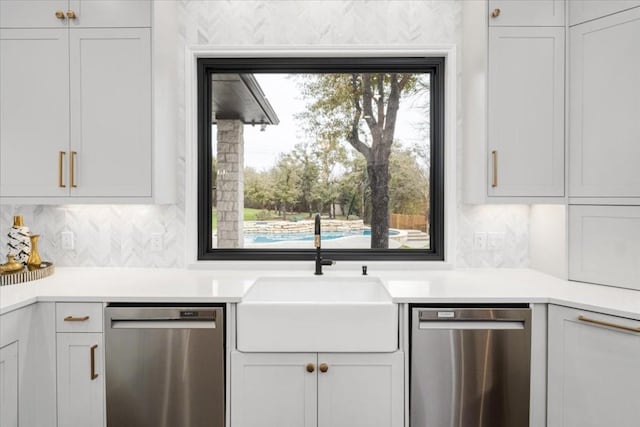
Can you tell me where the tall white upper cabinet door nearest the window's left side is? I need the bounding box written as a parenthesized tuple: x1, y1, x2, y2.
(69, 28, 152, 198)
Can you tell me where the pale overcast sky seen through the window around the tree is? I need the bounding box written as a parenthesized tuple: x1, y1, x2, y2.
(213, 74, 427, 171)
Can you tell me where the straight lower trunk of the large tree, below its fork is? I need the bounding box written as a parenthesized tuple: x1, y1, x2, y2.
(367, 163, 389, 249)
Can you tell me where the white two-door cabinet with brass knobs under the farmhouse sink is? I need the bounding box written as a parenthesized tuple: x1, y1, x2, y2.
(231, 352, 404, 427)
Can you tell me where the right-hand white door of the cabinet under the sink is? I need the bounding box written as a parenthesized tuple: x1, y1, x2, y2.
(318, 352, 404, 427)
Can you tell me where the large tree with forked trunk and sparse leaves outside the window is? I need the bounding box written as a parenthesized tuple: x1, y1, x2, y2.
(300, 73, 417, 248)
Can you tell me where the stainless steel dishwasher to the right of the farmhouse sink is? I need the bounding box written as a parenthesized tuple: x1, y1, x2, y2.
(410, 307, 531, 427)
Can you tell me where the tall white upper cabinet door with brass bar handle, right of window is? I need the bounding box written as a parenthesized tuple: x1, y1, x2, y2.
(487, 27, 564, 197)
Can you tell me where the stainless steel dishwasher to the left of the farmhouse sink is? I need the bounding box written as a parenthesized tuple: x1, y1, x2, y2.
(105, 304, 225, 427)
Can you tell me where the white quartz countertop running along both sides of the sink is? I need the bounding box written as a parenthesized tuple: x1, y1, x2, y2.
(0, 268, 640, 319)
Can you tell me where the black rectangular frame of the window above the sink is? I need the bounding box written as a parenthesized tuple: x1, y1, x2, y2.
(197, 56, 445, 261)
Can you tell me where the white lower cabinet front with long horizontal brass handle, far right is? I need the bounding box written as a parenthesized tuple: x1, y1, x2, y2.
(548, 305, 640, 427)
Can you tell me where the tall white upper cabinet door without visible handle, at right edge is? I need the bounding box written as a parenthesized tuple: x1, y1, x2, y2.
(569, 8, 640, 197)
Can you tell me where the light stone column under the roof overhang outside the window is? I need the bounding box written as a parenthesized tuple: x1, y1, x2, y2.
(216, 120, 244, 248)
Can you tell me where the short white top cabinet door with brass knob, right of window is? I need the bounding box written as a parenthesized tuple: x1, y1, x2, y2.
(489, 0, 565, 27)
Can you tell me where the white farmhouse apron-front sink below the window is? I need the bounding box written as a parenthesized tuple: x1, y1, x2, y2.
(237, 276, 398, 352)
